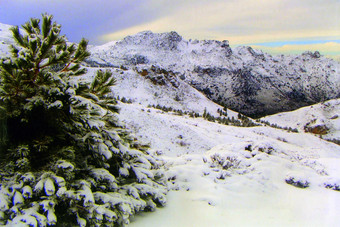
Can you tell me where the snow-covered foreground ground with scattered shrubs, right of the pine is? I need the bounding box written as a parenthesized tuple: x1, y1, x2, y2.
(120, 104, 340, 226)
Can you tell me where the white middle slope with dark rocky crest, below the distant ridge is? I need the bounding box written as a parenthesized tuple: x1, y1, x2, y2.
(87, 64, 238, 118)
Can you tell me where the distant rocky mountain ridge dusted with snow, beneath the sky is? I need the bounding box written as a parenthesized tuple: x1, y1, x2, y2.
(89, 31, 340, 116)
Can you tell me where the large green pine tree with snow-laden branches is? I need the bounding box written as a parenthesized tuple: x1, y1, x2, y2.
(0, 14, 167, 226)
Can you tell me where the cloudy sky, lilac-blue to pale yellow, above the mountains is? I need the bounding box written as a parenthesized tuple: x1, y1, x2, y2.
(0, 0, 340, 56)
